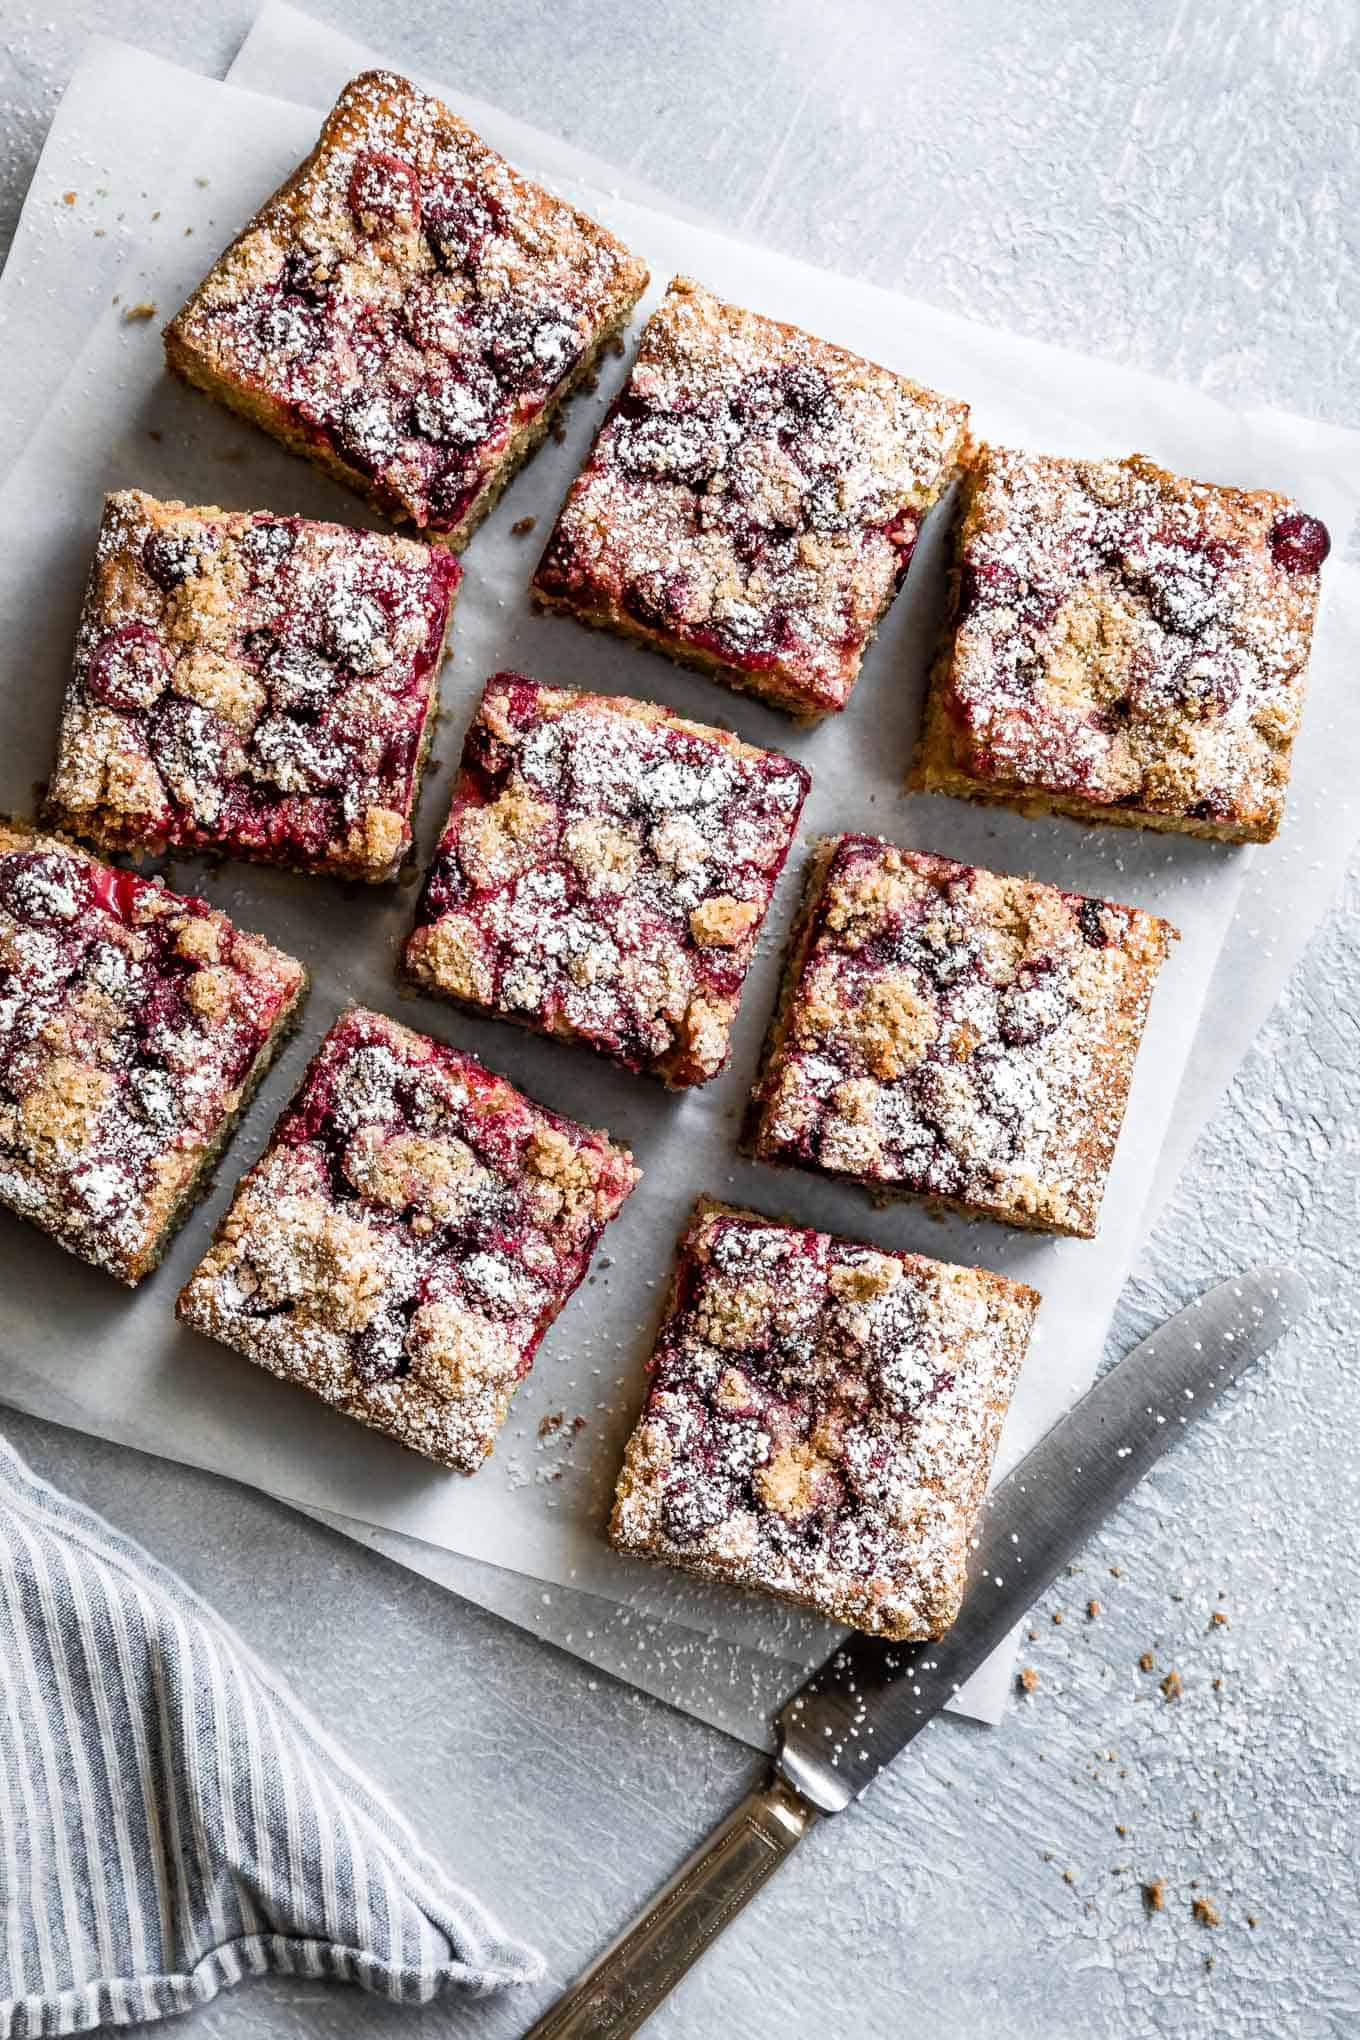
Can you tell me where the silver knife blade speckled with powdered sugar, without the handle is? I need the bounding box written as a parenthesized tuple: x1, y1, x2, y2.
(777, 1267, 1309, 1814)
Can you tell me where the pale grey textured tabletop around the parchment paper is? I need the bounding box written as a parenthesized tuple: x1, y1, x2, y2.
(0, 0, 1360, 2040)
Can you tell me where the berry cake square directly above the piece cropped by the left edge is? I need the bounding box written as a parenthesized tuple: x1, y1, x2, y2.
(49, 490, 461, 883)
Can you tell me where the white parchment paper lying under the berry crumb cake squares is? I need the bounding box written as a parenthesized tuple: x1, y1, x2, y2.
(0, 19, 1360, 1716)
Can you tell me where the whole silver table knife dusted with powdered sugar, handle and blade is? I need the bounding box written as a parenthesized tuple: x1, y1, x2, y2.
(524, 1267, 1309, 2040)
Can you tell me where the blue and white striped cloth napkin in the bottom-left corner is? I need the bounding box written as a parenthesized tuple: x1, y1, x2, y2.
(0, 1438, 542, 2040)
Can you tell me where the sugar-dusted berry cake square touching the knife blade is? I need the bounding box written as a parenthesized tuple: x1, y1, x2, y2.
(610, 1197, 1040, 1642)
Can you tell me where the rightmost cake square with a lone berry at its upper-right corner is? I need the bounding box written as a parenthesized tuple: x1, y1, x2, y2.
(911, 447, 1331, 843)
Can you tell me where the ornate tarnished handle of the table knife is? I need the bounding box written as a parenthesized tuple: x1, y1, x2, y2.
(524, 1779, 818, 2040)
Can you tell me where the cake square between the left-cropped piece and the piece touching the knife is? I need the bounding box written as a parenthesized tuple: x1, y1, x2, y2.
(177, 1006, 638, 1473)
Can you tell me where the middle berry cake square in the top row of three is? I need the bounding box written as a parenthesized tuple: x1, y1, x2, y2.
(532, 277, 969, 720)
